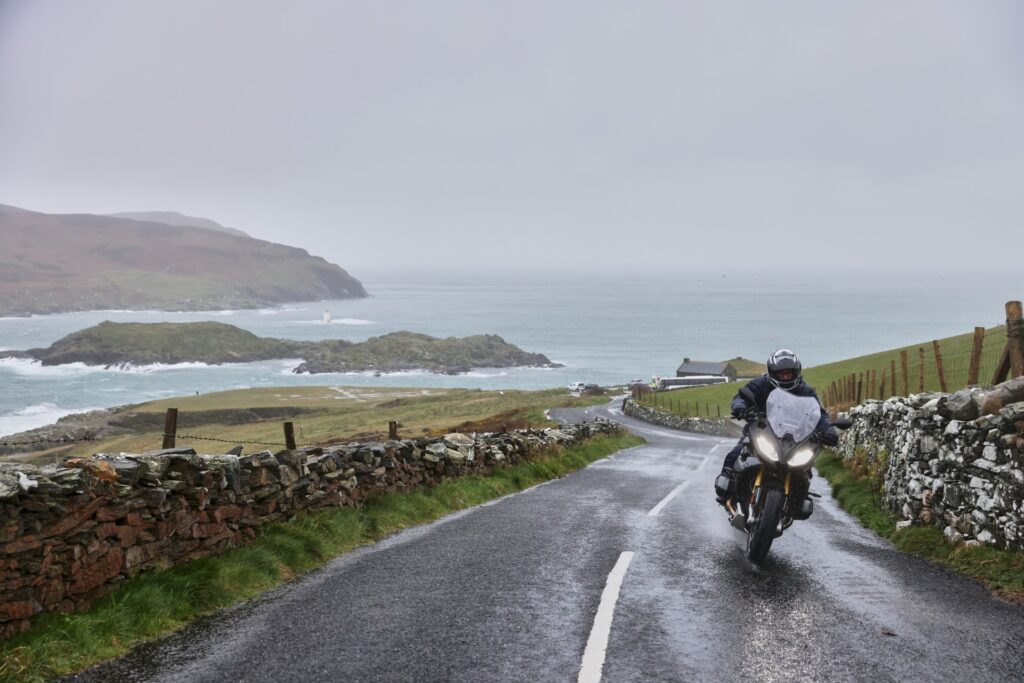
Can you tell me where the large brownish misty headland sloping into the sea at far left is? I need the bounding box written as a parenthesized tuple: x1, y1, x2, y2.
(0, 205, 367, 315)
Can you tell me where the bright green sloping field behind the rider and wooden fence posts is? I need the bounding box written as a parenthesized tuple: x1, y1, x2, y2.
(641, 326, 1007, 417)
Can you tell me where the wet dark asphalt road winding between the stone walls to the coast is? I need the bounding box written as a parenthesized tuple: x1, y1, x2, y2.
(68, 401, 1024, 682)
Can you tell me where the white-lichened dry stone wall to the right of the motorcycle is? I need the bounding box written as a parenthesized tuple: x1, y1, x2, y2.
(839, 387, 1024, 550)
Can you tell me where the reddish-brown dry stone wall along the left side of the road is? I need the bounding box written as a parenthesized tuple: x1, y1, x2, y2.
(0, 422, 623, 638)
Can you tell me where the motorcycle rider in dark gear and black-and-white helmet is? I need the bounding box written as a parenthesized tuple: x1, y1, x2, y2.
(715, 348, 839, 505)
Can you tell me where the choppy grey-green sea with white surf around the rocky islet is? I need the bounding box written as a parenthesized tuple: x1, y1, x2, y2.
(0, 265, 1007, 435)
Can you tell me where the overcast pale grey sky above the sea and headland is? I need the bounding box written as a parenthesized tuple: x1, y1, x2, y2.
(0, 0, 1024, 275)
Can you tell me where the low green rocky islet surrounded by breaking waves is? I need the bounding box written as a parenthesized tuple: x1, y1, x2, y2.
(9, 321, 558, 375)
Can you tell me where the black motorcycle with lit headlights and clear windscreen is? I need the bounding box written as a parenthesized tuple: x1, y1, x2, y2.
(722, 390, 853, 564)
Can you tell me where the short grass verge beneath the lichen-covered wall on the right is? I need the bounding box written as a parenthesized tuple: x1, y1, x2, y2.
(815, 451, 1024, 604)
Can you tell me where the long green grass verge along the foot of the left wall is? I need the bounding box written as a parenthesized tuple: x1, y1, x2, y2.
(0, 434, 643, 682)
